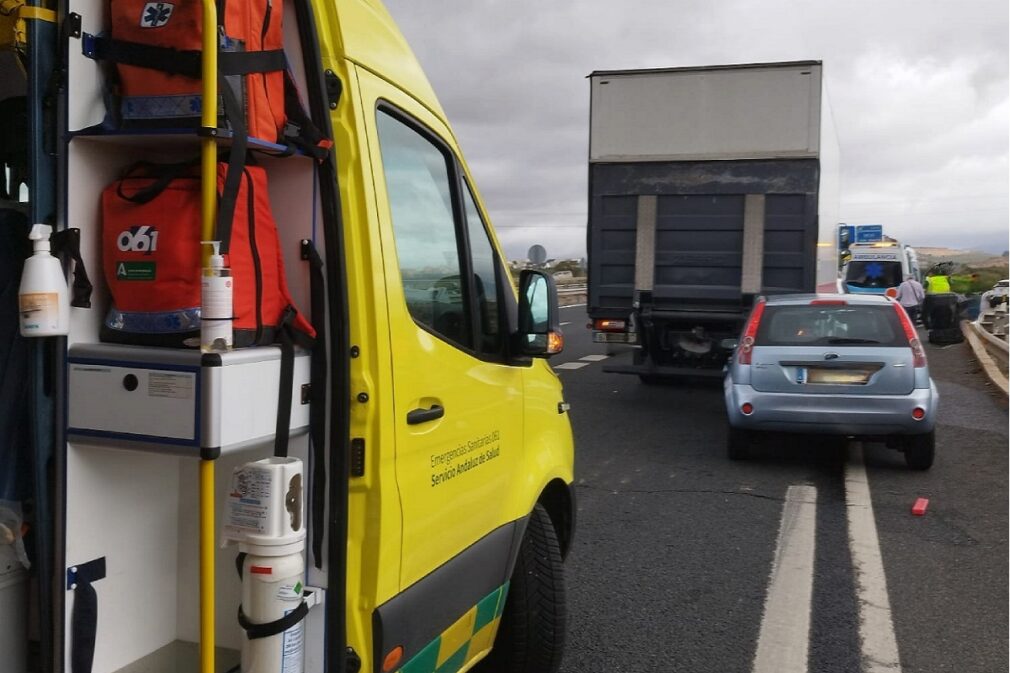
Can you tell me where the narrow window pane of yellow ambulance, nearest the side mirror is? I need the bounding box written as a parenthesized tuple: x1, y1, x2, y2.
(463, 183, 501, 355)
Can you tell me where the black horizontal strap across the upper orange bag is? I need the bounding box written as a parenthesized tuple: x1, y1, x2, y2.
(85, 35, 288, 80)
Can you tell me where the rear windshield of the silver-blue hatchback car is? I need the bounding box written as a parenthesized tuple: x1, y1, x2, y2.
(754, 304, 908, 347)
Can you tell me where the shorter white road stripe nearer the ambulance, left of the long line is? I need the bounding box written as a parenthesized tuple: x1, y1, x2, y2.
(751, 485, 817, 673)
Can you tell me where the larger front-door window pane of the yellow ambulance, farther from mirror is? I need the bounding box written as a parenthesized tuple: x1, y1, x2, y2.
(377, 110, 472, 347)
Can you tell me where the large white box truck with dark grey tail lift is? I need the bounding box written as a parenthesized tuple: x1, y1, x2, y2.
(587, 61, 838, 381)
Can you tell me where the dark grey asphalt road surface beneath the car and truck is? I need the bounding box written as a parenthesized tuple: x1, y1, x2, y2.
(551, 306, 1010, 673)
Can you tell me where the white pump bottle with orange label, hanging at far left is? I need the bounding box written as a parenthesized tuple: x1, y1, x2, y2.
(18, 224, 70, 337)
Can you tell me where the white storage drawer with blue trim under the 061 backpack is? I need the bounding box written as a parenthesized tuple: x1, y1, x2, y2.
(67, 344, 310, 459)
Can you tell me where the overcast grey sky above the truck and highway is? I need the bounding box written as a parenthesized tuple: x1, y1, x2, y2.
(387, 0, 1010, 258)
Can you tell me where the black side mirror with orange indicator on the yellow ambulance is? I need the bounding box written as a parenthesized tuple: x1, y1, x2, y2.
(513, 269, 565, 358)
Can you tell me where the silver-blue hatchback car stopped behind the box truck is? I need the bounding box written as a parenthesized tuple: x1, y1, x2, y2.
(724, 294, 938, 470)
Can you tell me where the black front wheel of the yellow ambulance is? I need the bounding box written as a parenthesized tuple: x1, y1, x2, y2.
(475, 504, 567, 673)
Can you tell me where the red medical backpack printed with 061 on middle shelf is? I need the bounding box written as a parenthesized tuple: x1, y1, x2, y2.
(101, 163, 315, 347)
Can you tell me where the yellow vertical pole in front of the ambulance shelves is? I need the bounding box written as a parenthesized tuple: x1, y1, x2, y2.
(200, 0, 217, 673)
